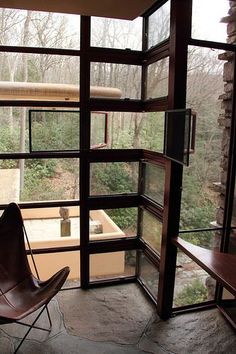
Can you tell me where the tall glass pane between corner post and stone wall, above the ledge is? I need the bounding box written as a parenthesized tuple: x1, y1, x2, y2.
(181, 46, 230, 229)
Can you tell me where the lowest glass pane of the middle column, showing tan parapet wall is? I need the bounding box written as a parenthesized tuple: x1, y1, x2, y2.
(90, 251, 136, 281)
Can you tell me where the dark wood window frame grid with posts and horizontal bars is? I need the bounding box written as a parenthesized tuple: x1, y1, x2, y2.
(0, 0, 236, 328)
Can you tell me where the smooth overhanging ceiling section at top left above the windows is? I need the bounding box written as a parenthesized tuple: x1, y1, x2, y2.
(0, 0, 159, 20)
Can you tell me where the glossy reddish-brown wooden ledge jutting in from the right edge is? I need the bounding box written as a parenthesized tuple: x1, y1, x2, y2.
(172, 237, 236, 296)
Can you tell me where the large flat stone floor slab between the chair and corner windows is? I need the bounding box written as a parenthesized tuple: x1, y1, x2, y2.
(58, 284, 155, 344)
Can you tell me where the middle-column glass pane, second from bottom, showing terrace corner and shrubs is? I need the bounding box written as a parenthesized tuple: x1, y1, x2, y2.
(90, 208, 138, 240)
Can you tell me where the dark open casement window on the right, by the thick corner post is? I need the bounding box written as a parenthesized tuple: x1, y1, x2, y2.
(164, 109, 196, 166)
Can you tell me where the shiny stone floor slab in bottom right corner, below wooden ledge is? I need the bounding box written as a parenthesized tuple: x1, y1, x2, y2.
(140, 309, 236, 354)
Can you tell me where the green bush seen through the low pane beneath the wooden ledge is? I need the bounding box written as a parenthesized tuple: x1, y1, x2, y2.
(175, 279, 207, 307)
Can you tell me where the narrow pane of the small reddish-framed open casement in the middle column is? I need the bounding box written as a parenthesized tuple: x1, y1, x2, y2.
(90, 112, 108, 149)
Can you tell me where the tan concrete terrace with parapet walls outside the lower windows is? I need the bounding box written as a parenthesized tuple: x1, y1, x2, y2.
(22, 207, 125, 280)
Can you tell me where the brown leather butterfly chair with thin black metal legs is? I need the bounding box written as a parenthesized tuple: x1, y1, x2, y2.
(0, 203, 70, 353)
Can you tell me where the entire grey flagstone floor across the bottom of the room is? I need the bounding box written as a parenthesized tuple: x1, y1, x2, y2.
(0, 284, 236, 354)
